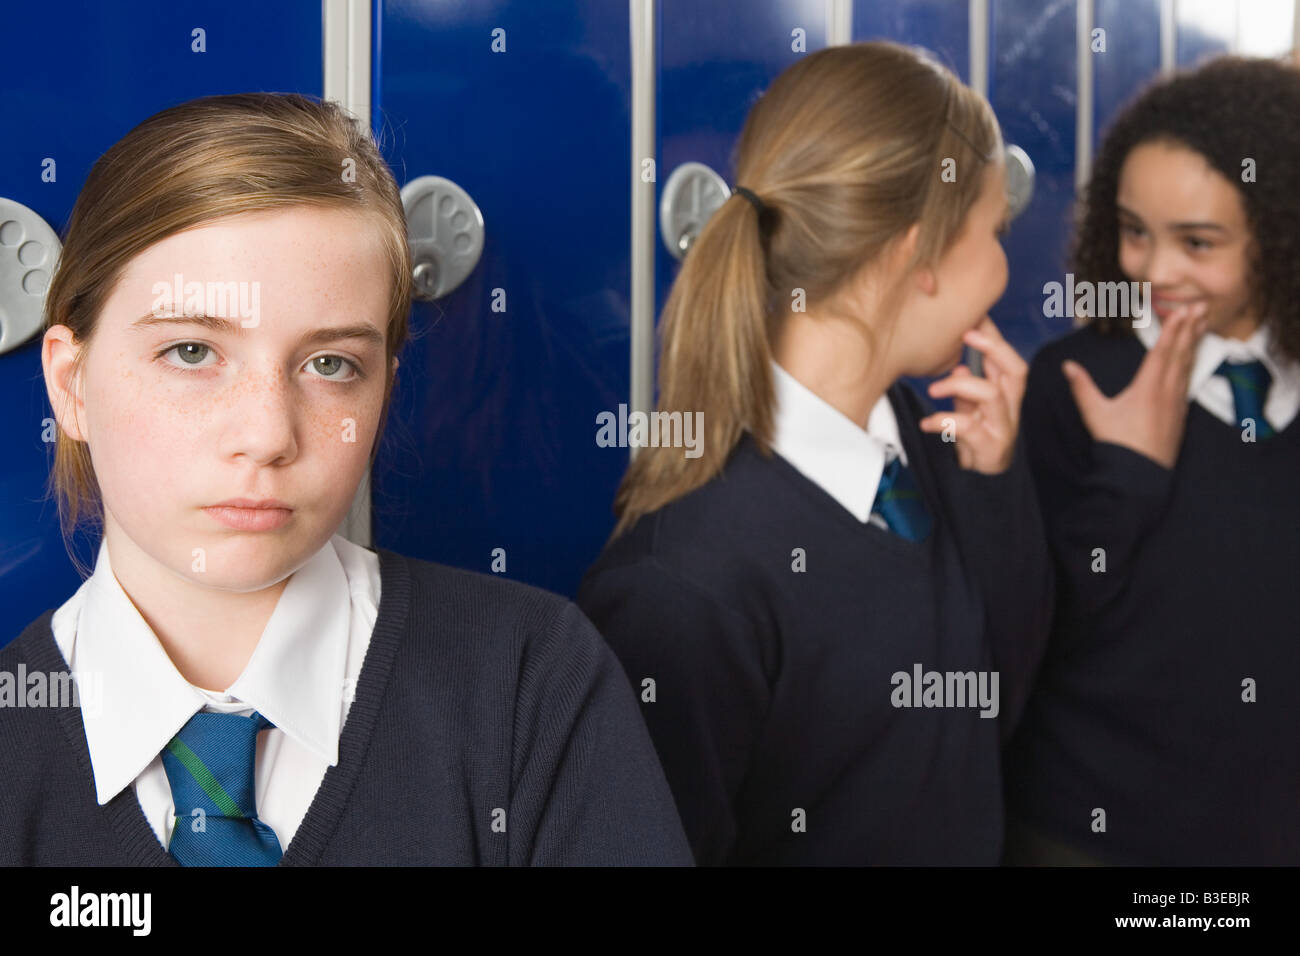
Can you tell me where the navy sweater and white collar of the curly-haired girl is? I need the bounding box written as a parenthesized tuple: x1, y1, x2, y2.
(1008, 317, 1300, 865)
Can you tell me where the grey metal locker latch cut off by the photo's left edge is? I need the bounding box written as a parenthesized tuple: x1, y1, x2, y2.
(0, 198, 64, 355)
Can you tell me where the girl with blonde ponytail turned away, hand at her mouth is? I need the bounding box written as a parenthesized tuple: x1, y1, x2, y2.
(579, 43, 1052, 864)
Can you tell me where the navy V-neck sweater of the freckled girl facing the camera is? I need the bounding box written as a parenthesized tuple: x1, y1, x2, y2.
(0, 549, 690, 866)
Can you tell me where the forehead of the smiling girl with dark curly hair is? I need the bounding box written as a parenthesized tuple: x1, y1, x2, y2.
(1117, 142, 1244, 222)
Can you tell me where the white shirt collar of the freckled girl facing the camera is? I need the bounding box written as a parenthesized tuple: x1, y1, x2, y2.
(52, 541, 351, 804)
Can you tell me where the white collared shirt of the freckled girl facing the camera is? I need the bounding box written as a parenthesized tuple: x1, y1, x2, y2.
(51, 535, 380, 849)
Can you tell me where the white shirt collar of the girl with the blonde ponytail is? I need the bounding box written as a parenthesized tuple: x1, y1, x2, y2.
(772, 362, 907, 527)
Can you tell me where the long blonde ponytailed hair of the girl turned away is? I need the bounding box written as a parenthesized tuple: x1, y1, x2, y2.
(614, 42, 1001, 537)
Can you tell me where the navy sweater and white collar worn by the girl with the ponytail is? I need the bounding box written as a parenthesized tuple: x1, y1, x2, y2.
(577, 364, 1050, 865)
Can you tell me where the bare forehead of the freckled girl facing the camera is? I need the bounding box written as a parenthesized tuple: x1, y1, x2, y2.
(109, 207, 391, 329)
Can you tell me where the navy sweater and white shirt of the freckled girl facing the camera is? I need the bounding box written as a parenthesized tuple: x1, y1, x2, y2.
(0, 535, 690, 866)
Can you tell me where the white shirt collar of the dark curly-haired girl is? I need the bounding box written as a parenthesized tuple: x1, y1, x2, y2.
(1134, 312, 1300, 432)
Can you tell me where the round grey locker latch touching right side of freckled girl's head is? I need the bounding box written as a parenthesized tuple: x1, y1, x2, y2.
(402, 176, 484, 302)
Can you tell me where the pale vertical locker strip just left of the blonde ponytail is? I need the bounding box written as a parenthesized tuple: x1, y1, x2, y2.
(628, 0, 659, 447)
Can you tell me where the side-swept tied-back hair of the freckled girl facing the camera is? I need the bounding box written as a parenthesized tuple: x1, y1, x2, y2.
(44, 92, 411, 572)
